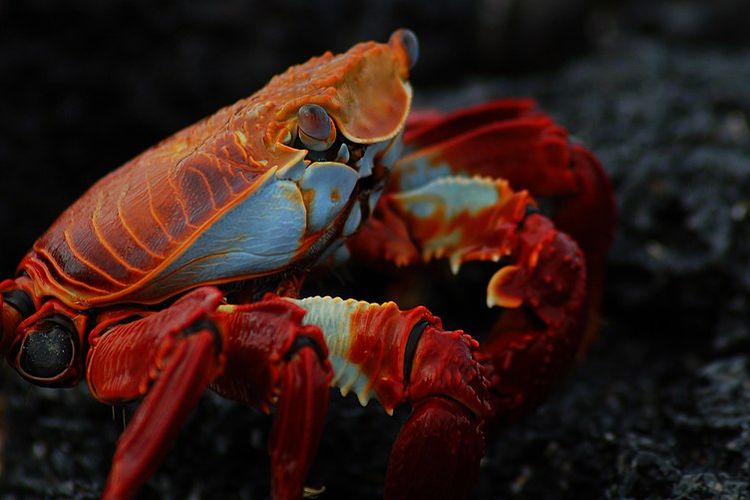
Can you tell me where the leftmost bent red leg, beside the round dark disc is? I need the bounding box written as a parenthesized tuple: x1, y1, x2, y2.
(86, 288, 223, 498)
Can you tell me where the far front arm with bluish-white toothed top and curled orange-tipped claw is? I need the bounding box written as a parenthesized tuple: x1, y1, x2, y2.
(352, 177, 587, 422)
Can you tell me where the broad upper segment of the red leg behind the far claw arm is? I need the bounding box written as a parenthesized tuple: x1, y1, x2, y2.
(400, 99, 578, 197)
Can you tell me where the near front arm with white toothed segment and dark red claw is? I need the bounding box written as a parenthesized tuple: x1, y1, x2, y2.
(294, 297, 490, 499)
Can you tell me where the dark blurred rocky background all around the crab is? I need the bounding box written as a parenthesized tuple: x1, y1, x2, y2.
(0, 0, 750, 498)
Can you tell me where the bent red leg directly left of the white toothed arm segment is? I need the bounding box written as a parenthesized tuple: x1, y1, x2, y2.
(212, 295, 333, 498)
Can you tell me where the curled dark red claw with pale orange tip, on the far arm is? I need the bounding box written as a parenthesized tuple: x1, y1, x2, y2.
(477, 214, 587, 424)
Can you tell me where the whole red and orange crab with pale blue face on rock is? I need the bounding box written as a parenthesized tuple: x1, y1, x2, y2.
(0, 30, 615, 498)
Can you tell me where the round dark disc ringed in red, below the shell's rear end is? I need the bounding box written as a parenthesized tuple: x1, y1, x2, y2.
(18, 318, 75, 380)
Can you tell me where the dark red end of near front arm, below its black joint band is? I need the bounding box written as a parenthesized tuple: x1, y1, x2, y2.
(385, 323, 489, 499)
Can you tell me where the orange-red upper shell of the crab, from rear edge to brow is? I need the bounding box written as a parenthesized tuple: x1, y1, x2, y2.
(19, 37, 411, 309)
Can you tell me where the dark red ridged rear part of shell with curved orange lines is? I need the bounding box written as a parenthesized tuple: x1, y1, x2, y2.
(27, 116, 274, 303)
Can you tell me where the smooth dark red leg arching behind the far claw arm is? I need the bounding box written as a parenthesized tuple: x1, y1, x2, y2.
(389, 99, 616, 350)
